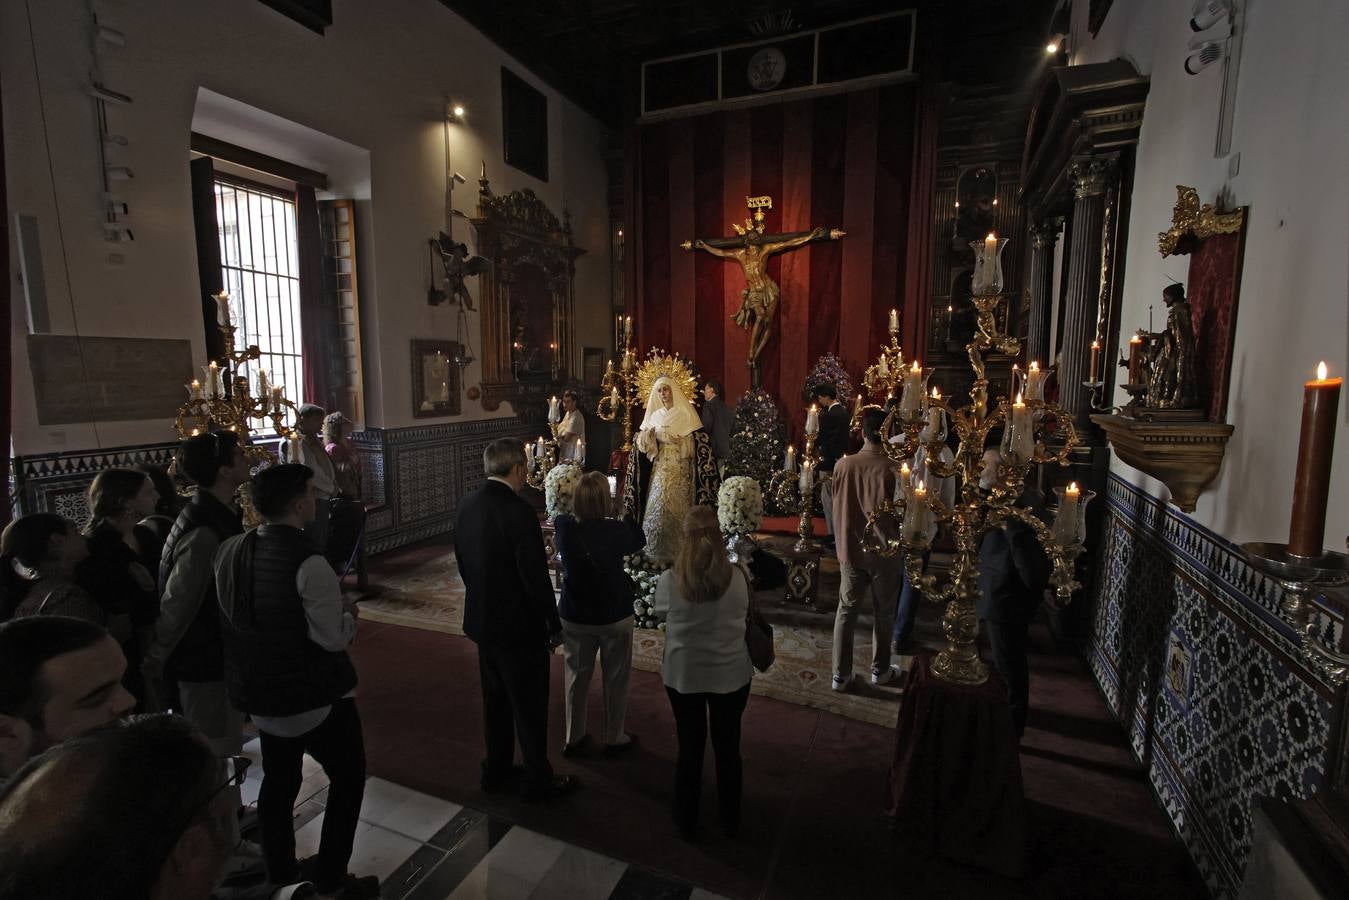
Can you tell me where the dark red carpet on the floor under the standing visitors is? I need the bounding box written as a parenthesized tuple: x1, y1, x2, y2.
(353, 542, 1205, 900)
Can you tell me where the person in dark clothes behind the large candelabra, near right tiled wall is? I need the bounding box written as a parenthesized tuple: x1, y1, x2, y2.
(975, 488, 1050, 738)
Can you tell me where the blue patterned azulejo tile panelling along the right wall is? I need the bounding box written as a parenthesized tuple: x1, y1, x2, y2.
(1087, 475, 1342, 897)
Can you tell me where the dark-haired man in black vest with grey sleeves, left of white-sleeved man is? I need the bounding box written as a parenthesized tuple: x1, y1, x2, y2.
(142, 432, 248, 758)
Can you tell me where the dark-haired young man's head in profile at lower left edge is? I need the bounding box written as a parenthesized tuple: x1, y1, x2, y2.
(0, 615, 136, 780)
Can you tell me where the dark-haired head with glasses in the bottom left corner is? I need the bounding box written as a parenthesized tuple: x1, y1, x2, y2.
(0, 715, 237, 900)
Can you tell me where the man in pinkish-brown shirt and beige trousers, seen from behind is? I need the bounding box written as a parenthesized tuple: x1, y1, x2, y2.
(831, 406, 902, 691)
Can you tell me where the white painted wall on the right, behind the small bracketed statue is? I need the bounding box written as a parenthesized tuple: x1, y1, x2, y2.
(1072, 0, 1349, 551)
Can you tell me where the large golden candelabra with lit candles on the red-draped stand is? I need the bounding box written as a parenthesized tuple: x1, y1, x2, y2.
(863, 235, 1094, 684)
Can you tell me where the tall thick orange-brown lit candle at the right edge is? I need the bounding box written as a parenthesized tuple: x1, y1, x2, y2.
(1288, 363, 1344, 556)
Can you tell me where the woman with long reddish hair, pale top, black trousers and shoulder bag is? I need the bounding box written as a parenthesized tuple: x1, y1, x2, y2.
(654, 506, 753, 841)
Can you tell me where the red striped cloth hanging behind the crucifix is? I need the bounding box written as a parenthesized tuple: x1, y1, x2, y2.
(626, 85, 931, 441)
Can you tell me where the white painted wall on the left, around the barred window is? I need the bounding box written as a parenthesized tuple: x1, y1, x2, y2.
(0, 0, 610, 453)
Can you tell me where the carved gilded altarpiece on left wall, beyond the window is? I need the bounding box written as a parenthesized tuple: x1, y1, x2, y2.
(472, 173, 585, 413)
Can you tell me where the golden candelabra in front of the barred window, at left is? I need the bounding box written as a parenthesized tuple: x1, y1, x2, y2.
(174, 291, 295, 463)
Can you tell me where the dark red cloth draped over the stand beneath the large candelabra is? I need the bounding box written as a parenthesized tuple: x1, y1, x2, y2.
(885, 656, 1027, 878)
